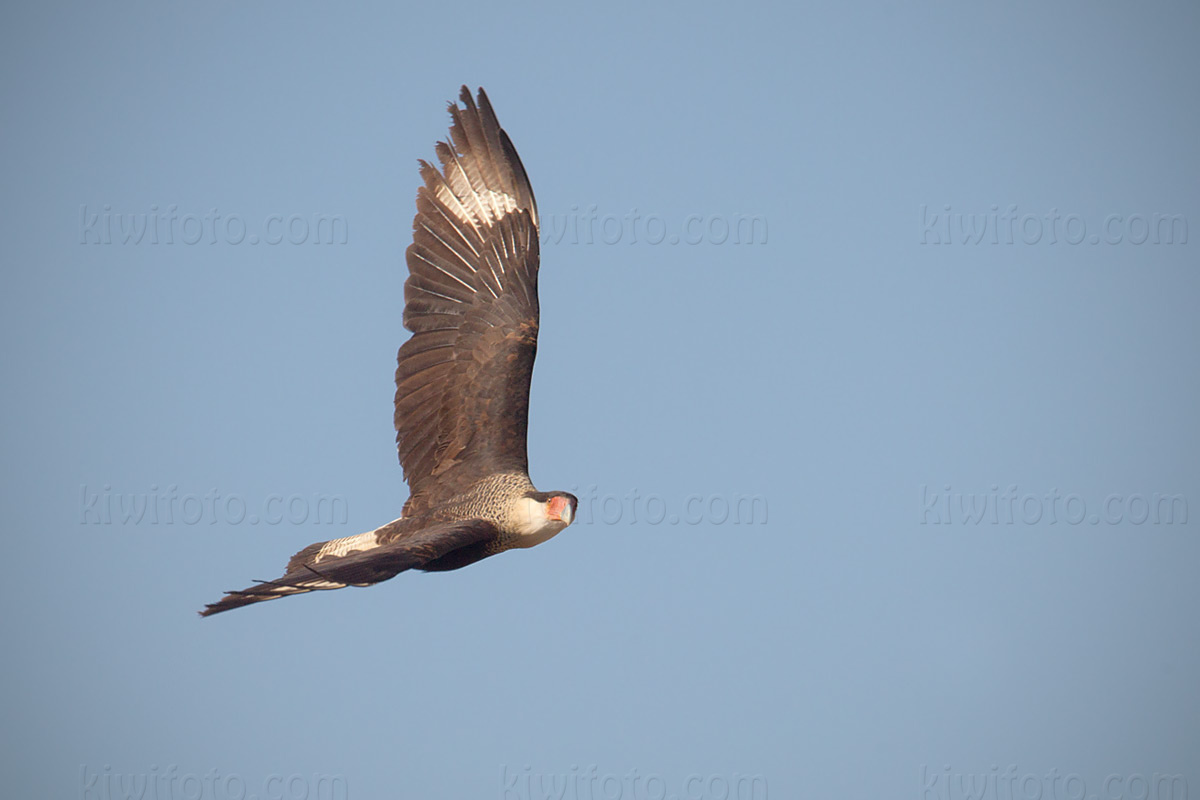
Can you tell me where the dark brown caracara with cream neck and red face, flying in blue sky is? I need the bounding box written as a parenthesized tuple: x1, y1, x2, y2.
(200, 86, 578, 616)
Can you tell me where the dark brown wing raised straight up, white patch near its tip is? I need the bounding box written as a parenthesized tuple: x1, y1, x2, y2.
(395, 86, 538, 517)
